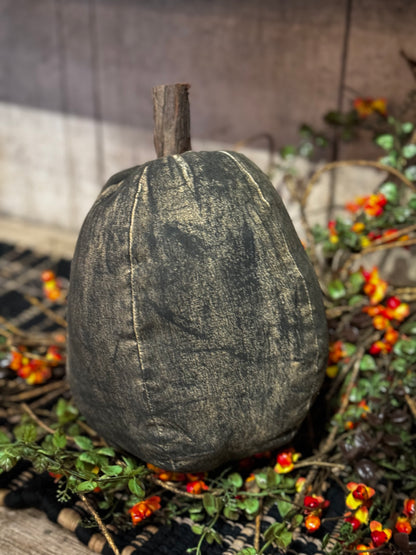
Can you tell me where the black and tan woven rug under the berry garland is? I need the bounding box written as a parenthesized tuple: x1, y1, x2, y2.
(0, 243, 344, 555)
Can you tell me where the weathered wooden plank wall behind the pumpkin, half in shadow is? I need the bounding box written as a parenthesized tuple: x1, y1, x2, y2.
(0, 0, 416, 230)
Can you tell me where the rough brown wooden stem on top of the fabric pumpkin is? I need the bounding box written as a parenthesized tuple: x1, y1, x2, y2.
(153, 83, 191, 158)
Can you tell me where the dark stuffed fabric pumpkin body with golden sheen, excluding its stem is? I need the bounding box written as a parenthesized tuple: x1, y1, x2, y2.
(68, 151, 327, 471)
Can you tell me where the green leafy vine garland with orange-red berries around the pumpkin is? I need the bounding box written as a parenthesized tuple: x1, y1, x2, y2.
(0, 99, 416, 555)
